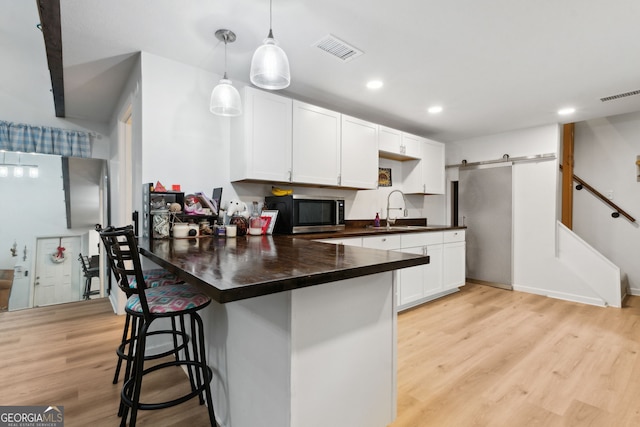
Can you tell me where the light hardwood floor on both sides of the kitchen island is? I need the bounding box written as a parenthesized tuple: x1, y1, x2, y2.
(0, 284, 640, 427)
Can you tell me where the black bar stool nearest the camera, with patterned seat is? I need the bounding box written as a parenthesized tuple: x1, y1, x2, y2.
(96, 226, 216, 427)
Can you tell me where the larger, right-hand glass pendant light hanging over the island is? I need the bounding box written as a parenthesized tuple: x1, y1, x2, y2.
(249, 0, 291, 90)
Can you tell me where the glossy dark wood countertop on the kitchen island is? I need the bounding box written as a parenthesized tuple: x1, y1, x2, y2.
(140, 235, 429, 303)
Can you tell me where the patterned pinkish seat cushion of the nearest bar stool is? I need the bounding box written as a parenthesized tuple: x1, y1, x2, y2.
(127, 285, 211, 313)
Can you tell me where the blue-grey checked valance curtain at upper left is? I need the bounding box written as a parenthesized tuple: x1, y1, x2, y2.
(0, 120, 91, 157)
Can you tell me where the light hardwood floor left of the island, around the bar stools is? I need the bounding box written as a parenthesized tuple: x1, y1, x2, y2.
(0, 299, 209, 427)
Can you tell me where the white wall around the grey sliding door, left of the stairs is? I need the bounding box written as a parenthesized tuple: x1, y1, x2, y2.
(446, 125, 598, 303)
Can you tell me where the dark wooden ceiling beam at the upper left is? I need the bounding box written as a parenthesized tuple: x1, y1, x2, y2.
(37, 0, 65, 117)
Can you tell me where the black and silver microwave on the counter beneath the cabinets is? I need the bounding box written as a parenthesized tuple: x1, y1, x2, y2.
(265, 194, 344, 234)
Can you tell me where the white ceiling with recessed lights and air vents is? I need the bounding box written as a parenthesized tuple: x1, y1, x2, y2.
(22, 0, 640, 141)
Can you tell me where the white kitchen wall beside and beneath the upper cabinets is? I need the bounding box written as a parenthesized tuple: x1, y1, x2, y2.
(136, 52, 444, 227)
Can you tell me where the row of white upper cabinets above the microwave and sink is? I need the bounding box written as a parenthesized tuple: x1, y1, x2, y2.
(230, 86, 445, 194)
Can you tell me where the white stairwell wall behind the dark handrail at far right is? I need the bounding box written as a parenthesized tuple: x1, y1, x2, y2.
(573, 112, 640, 295)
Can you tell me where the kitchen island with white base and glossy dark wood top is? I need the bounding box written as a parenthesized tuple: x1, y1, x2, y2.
(140, 236, 429, 427)
